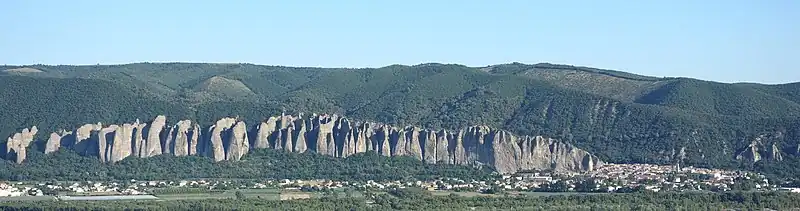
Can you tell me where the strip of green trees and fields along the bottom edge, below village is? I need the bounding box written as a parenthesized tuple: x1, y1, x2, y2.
(0, 188, 800, 210)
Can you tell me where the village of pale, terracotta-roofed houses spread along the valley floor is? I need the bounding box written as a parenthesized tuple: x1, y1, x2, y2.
(0, 164, 800, 197)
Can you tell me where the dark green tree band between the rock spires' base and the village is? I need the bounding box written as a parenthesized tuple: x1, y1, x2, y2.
(0, 149, 493, 181)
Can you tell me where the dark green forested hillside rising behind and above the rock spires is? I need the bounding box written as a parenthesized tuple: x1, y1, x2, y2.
(0, 63, 800, 176)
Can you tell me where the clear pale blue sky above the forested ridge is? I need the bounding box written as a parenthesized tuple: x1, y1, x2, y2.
(0, 0, 800, 83)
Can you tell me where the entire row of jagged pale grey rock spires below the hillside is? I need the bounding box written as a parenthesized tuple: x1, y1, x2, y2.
(0, 114, 603, 173)
